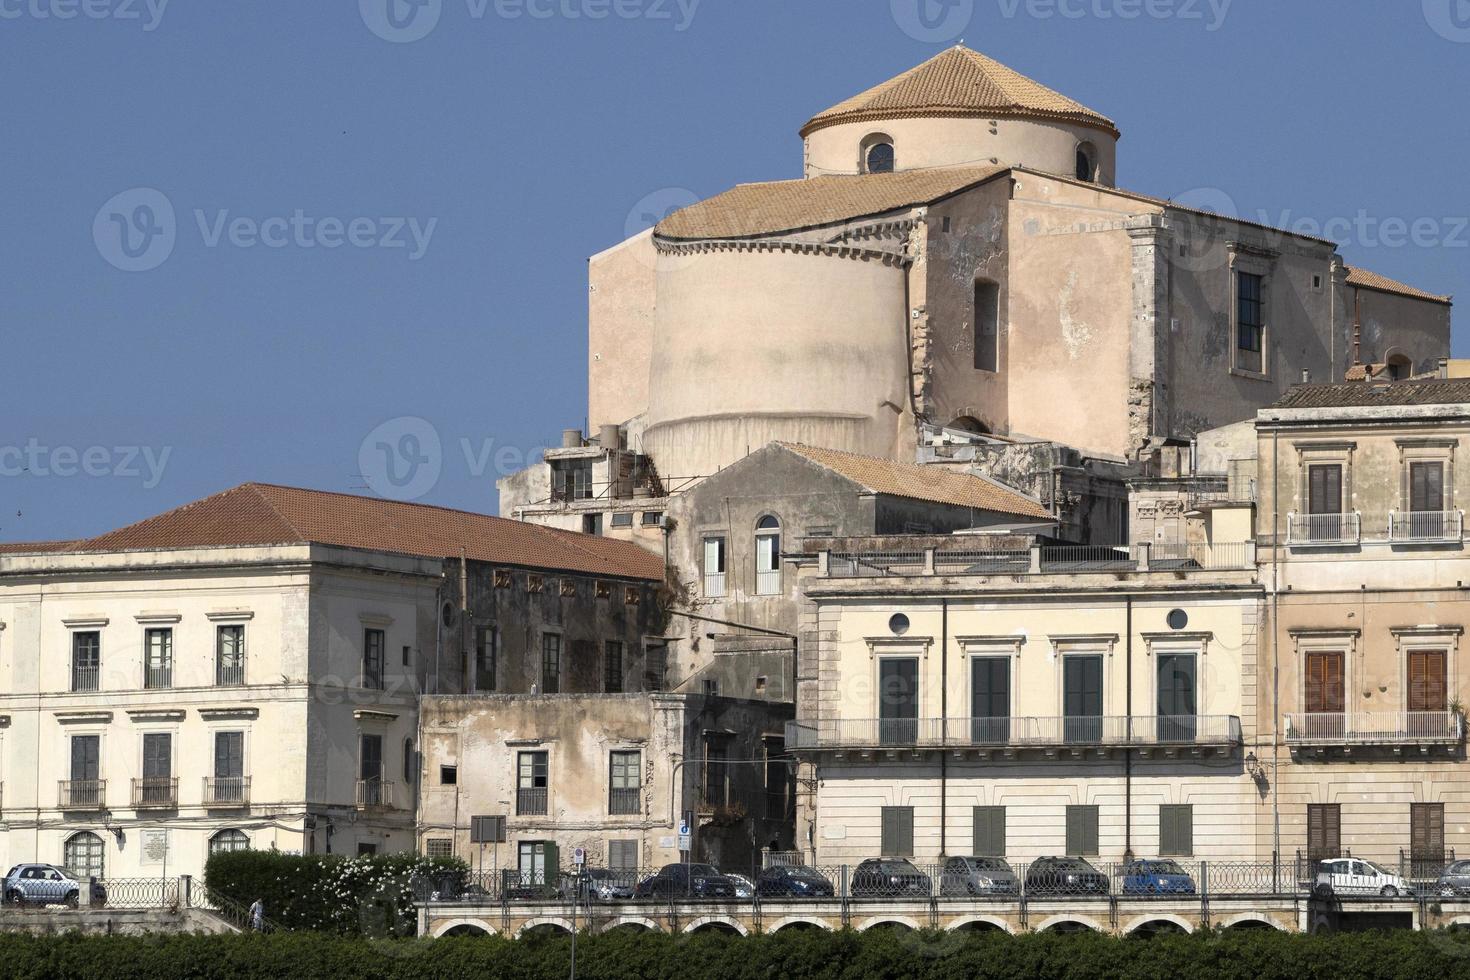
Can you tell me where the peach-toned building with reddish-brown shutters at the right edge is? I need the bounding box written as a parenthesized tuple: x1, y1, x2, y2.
(1257, 379, 1470, 877)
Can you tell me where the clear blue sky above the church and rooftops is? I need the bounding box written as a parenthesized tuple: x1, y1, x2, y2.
(0, 0, 1470, 541)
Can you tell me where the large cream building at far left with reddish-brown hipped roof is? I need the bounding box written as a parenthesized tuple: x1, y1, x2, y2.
(0, 483, 662, 879)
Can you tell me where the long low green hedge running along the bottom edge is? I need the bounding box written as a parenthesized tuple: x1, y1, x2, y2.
(0, 930, 1470, 980)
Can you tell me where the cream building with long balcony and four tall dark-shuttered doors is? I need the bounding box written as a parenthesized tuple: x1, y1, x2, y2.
(788, 536, 1269, 864)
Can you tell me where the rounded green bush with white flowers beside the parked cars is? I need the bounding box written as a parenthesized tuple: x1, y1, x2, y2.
(204, 851, 465, 937)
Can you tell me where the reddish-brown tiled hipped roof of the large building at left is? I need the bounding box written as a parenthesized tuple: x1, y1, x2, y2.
(45, 483, 663, 580)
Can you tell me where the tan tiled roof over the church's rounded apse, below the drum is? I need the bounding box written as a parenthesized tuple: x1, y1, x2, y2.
(654, 166, 1007, 239)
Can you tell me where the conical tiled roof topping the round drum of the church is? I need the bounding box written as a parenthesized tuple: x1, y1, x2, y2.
(801, 46, 1119, 138)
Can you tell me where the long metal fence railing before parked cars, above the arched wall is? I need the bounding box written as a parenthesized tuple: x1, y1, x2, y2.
(413, 854, 1470, 905)
